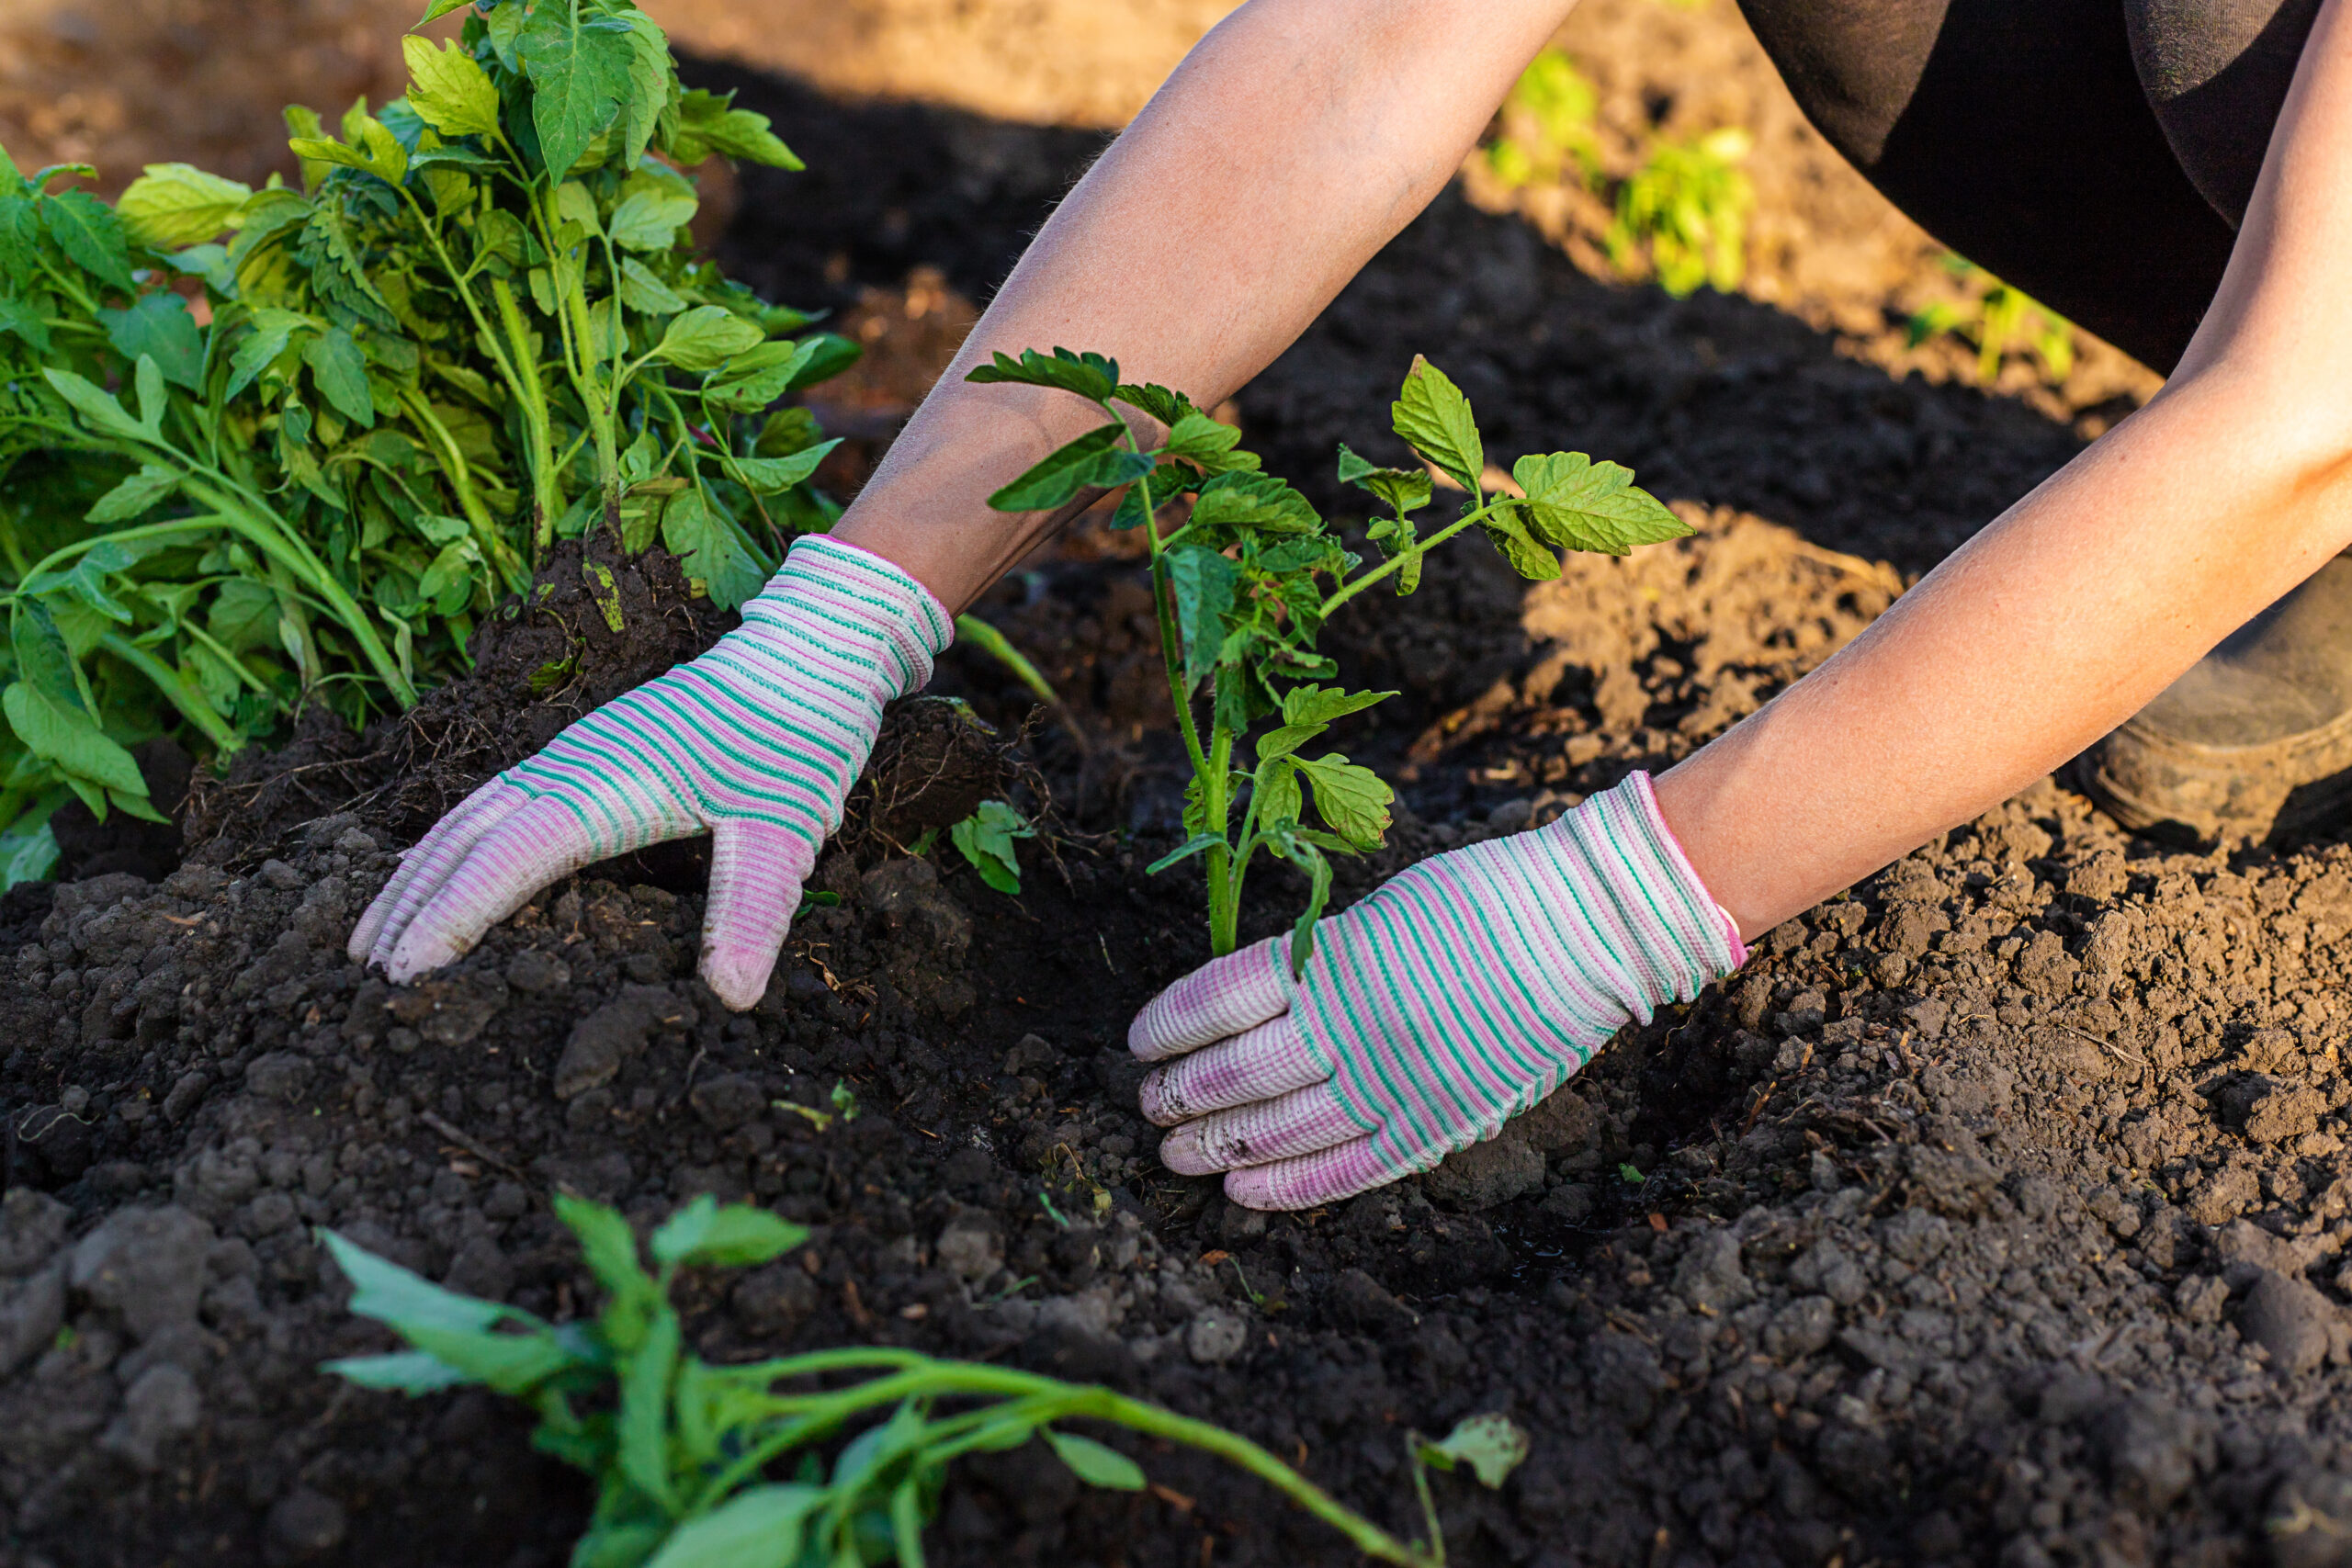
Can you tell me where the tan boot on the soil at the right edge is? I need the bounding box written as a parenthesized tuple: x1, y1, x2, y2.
(2076, 558, 2352, 841)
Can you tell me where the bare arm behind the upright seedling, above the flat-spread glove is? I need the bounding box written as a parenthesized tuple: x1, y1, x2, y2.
(835, 0, 1571, 609)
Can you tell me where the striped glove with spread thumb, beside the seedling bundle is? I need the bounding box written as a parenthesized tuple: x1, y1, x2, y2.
(350, 536, 953, 1009)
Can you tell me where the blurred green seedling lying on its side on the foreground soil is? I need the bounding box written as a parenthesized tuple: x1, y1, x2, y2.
(322, 1194, 1526, 1568)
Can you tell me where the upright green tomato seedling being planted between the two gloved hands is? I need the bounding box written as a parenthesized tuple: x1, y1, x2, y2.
(969, 348, 1691, 966)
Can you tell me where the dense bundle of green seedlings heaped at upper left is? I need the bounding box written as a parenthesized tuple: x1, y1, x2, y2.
(0, 0, 858, 884)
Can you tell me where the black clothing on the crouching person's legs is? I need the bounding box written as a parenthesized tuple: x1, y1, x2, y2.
(1740, 0, 2319, 371)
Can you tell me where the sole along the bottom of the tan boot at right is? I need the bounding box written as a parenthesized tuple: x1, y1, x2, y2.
(2075, 710, 2352, 844)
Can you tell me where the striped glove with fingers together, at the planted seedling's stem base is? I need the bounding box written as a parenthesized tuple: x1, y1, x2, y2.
(1126, 773, 1747, 1208)
